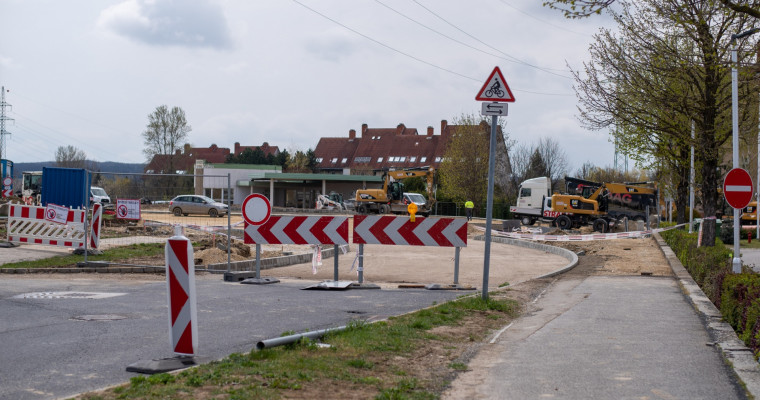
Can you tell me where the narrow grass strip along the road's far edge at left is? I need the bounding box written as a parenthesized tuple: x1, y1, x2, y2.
(0, 243, 164, 268)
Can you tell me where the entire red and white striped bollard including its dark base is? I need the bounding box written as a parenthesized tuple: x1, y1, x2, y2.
(127, 226, 208, 374)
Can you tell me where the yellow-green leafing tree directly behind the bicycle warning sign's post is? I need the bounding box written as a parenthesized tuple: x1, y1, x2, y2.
(439, 115, 511, 207)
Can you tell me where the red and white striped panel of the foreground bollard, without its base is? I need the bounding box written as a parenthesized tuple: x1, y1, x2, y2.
(165, 226, 198, 355)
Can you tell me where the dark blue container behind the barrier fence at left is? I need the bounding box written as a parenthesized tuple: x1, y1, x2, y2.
(42, 167, 90, 209)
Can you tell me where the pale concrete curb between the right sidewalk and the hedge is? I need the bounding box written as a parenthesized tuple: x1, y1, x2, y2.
(654, 233, 760, 398)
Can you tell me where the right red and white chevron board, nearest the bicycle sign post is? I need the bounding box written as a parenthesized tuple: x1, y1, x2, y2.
(353, 215, 467, 247)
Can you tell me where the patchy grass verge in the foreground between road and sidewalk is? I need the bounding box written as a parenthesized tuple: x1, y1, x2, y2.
(75, 297, 517, 400)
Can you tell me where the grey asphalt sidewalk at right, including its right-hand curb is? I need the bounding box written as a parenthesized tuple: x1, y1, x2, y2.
(443, 236, 760, 399)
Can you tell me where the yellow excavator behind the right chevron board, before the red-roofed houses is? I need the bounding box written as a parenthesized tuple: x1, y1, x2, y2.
(356, 167, 435, 217)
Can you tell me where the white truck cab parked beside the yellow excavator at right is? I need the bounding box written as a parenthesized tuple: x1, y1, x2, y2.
(509, 176, 560, 225)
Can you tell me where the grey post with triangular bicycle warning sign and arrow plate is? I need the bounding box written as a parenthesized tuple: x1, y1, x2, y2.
(475, 66, 515, 300)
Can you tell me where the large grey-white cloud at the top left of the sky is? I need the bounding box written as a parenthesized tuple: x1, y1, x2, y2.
(98, 0, 232, 49)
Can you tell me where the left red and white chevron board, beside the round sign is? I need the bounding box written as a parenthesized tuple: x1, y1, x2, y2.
(243, 216, 348, 244)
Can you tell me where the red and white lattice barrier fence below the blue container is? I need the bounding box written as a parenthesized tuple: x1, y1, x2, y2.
(8, 204, 85, 248)
